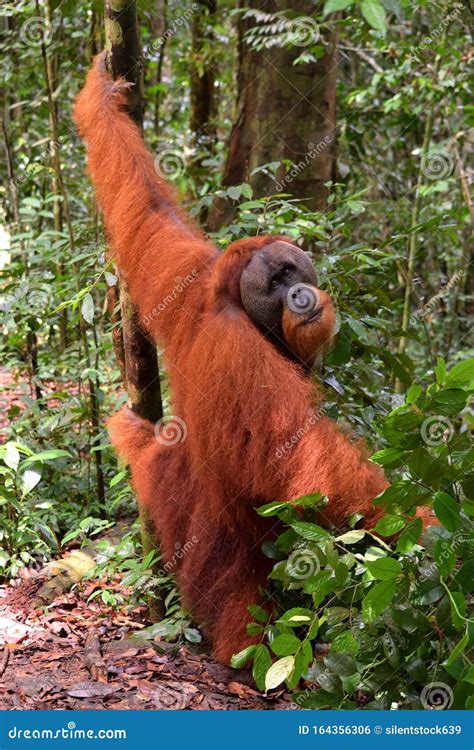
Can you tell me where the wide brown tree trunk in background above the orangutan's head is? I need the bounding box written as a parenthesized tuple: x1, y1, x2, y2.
(209, 0, 337, 230)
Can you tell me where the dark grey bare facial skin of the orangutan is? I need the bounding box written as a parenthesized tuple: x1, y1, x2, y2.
(240, 241, 318, 335)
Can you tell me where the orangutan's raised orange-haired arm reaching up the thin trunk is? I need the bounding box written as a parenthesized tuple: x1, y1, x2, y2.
(74, 53, 217, 343)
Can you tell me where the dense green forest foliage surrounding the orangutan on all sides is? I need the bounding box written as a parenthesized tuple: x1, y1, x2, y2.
(0, 0, 474, 708)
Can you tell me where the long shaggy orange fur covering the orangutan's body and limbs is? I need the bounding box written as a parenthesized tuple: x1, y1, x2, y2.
(75, 58, 416, 661)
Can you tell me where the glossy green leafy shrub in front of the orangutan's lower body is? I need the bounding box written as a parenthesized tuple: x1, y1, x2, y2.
(233, 360, 474, 709)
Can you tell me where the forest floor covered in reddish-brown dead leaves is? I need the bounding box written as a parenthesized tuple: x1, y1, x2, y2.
(0, 374, 290, 710)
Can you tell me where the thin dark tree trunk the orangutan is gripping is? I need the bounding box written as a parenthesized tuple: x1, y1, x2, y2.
(105, 0, 164, 620)
